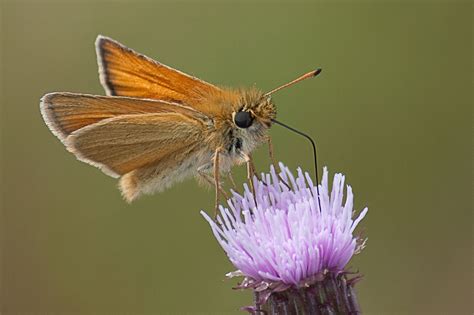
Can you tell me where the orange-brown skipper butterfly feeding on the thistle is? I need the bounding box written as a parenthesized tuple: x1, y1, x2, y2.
(40, 36, 321, 204)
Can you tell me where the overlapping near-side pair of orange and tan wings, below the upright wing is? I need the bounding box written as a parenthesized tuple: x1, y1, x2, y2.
(40, 93, 212, 181)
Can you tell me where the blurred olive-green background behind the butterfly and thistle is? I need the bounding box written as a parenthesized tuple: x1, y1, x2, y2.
(0, 0, 473, 314)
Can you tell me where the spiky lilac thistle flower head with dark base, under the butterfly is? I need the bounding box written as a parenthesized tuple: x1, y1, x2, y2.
(201, 163, 368, 314)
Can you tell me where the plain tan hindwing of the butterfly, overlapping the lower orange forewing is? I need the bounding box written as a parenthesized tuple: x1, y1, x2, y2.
(65, 113, 203, 175)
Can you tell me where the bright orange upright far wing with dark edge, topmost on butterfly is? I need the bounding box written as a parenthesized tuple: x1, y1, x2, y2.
(96, 36, 222, 108)
